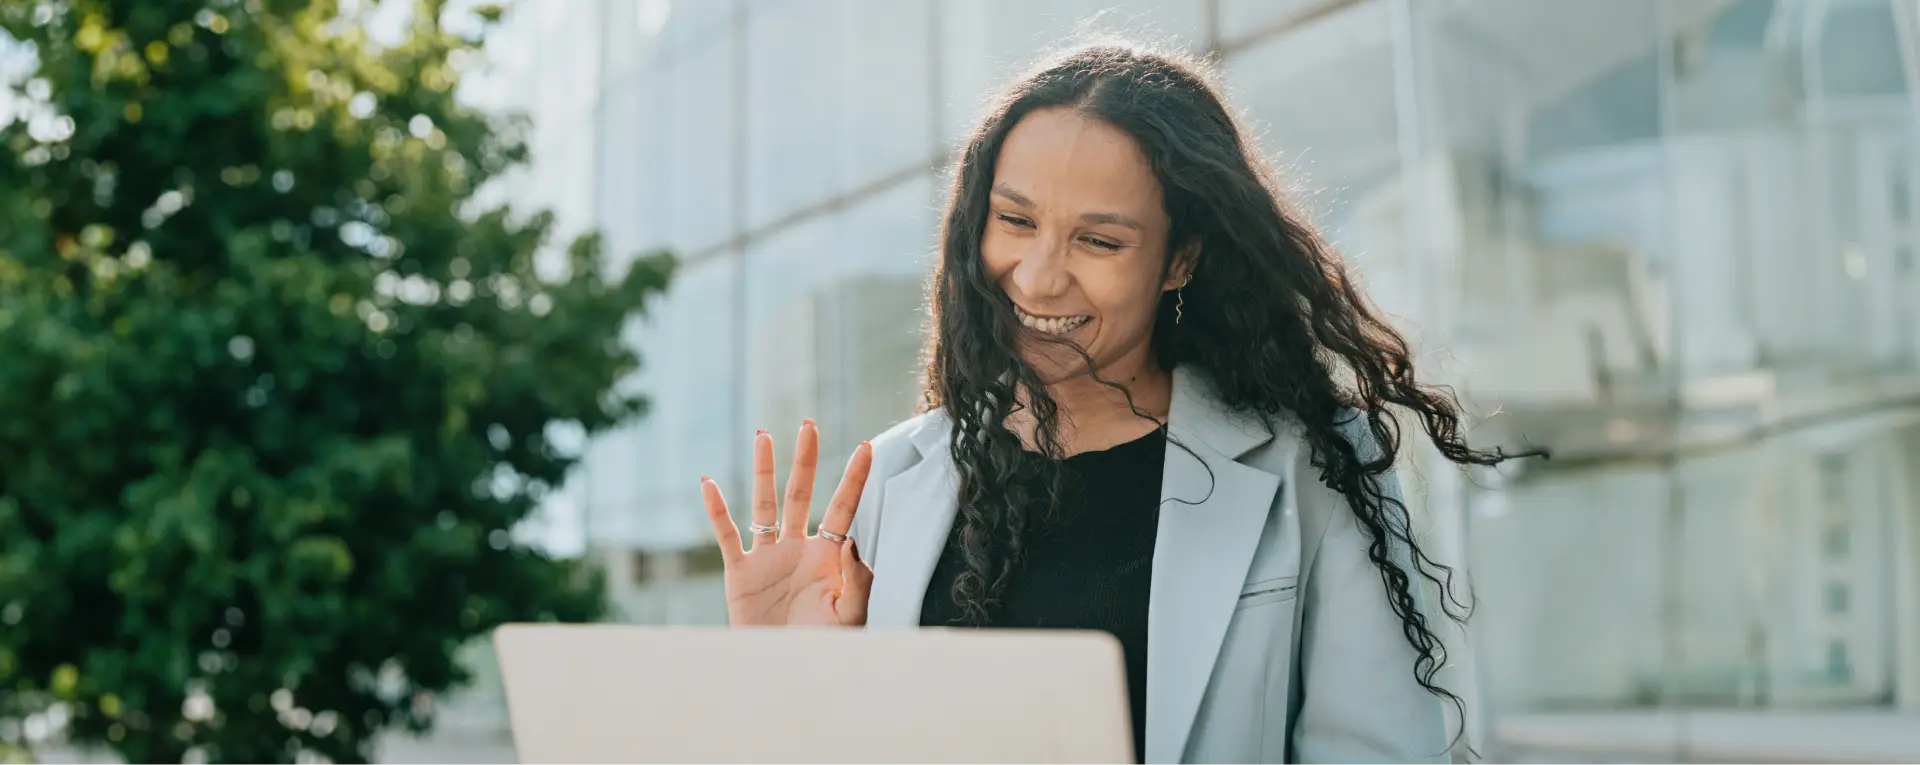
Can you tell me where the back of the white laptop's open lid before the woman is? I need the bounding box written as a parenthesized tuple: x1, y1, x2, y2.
(493, 625, 1133, 765)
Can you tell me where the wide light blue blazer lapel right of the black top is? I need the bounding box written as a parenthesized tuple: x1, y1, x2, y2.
(1142, 369, 1281, 765)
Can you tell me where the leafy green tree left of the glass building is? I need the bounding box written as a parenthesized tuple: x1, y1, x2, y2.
(0, 0, 672, 765)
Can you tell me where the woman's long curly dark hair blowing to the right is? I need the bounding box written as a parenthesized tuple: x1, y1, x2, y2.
(925, 44, 1536, 741)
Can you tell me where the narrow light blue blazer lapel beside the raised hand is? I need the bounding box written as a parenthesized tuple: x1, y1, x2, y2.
(866, 417, 960, 627)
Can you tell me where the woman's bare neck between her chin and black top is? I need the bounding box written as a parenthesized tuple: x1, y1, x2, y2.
(1006, 354, 1173, 456)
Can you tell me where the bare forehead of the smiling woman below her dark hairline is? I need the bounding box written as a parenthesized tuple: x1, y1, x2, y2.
(993, 108, 1164, 217)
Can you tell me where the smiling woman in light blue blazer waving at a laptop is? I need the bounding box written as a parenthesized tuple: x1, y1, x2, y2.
(703, 46, 1503, 765)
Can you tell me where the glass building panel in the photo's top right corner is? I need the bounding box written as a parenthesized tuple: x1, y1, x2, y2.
(1668, 0, 1916, 380)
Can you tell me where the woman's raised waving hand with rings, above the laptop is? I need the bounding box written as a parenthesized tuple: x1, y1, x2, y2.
(701, 419, 874, 627)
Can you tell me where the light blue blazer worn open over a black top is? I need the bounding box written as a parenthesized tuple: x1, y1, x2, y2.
(852, 371, 1448, 765)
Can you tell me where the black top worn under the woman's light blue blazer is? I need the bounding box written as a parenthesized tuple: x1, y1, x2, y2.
(920, 429, 1167, 761)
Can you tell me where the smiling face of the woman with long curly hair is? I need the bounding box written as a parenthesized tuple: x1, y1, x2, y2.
(981, 108, 1185, 384)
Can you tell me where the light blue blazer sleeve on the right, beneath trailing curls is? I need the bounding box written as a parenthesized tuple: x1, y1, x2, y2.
(1290, 457, 1448, 765)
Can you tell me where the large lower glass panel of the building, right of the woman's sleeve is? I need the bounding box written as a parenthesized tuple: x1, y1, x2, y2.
(1471, 421, 1910, 709)
